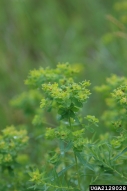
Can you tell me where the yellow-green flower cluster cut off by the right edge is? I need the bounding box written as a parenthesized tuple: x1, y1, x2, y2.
(96, 75, 127, 129)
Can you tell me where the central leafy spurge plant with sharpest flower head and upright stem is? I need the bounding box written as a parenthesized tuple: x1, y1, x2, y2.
(26, 63, 93, 190)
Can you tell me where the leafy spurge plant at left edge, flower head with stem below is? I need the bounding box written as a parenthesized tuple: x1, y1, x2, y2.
(0, 125, 28, 191)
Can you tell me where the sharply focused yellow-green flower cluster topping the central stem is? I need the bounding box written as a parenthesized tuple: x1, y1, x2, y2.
(40, 81, 90, 118)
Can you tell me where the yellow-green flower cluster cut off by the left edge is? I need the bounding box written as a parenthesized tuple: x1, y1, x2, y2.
(0, 126, 28, 165)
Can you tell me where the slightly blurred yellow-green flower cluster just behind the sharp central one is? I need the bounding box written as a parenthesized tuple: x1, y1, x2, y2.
(25, 63, 81, 89)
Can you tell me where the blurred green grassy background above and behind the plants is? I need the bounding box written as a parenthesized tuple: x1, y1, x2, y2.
(0, 0, 127, 129)
